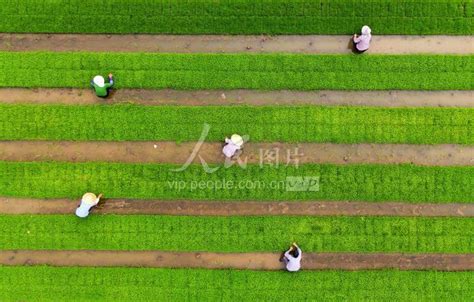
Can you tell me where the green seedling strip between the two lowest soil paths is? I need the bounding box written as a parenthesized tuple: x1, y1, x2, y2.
(0, 213, 474, 253)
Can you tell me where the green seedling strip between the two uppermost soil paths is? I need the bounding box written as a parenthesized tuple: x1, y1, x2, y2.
(0, 52, 473, 90)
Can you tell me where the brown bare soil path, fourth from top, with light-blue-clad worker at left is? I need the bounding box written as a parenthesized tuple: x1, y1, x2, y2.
(0, 197, 474, 217)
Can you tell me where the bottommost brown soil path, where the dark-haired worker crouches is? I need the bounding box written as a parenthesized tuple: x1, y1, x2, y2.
(0, 250, 474, 271)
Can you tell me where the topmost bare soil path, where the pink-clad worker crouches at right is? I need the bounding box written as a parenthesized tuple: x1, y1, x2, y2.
(0, 34, 474, 54)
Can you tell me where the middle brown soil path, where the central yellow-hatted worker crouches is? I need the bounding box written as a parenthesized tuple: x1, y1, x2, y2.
(0, 141, 474, 166)
